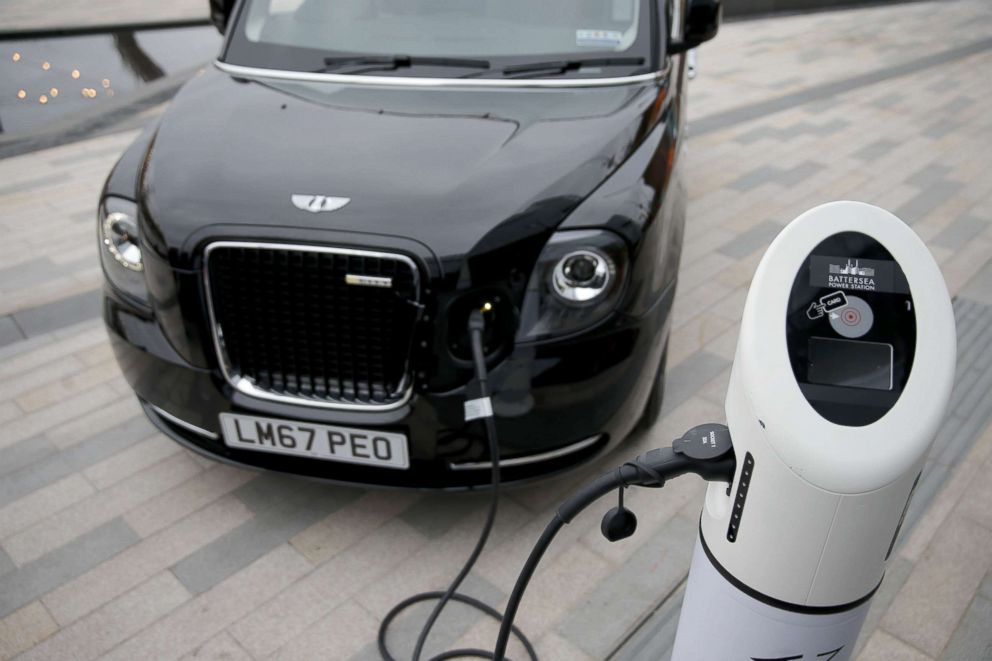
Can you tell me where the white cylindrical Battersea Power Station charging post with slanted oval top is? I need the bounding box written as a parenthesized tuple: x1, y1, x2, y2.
(672, 202, 956, 661)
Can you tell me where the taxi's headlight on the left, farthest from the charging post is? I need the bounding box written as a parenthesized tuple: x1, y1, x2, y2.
(98, 197, 148, 302)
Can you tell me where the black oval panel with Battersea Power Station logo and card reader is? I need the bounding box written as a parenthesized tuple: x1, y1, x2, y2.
(785, 231, 916, 427)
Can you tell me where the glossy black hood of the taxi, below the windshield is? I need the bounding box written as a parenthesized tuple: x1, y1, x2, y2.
(142, 69, 657, 260)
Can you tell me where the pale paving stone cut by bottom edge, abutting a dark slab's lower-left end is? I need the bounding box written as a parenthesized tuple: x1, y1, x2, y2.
(20, 572, 190, 661)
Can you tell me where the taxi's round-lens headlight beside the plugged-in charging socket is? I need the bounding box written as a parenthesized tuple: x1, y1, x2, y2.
(517, 230, 627, 342)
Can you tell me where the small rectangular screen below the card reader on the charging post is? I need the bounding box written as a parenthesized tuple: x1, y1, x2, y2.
(806, 337, 892, 390)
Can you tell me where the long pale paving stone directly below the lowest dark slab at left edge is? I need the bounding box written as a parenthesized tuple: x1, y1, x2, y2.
(42, 497, 251, 626)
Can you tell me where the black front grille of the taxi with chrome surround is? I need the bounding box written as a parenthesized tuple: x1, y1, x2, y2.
(206, 242, 419, 409)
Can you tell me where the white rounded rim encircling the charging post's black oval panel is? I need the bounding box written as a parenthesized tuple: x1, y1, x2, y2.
(731, 202, 956, 494)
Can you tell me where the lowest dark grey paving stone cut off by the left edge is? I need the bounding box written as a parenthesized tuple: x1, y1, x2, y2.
(0, 519, 138, 617)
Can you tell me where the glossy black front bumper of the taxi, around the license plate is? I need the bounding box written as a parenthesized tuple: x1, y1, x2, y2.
(103, 285, 675, 489)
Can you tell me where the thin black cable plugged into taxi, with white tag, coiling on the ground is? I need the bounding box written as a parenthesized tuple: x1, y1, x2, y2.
(378, 310, 537, 661)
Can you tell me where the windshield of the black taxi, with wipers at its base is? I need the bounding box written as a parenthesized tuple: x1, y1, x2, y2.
(222, 0, 657, 77)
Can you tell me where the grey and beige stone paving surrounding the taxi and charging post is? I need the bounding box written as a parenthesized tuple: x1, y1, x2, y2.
(0, 0, 992, 661)
